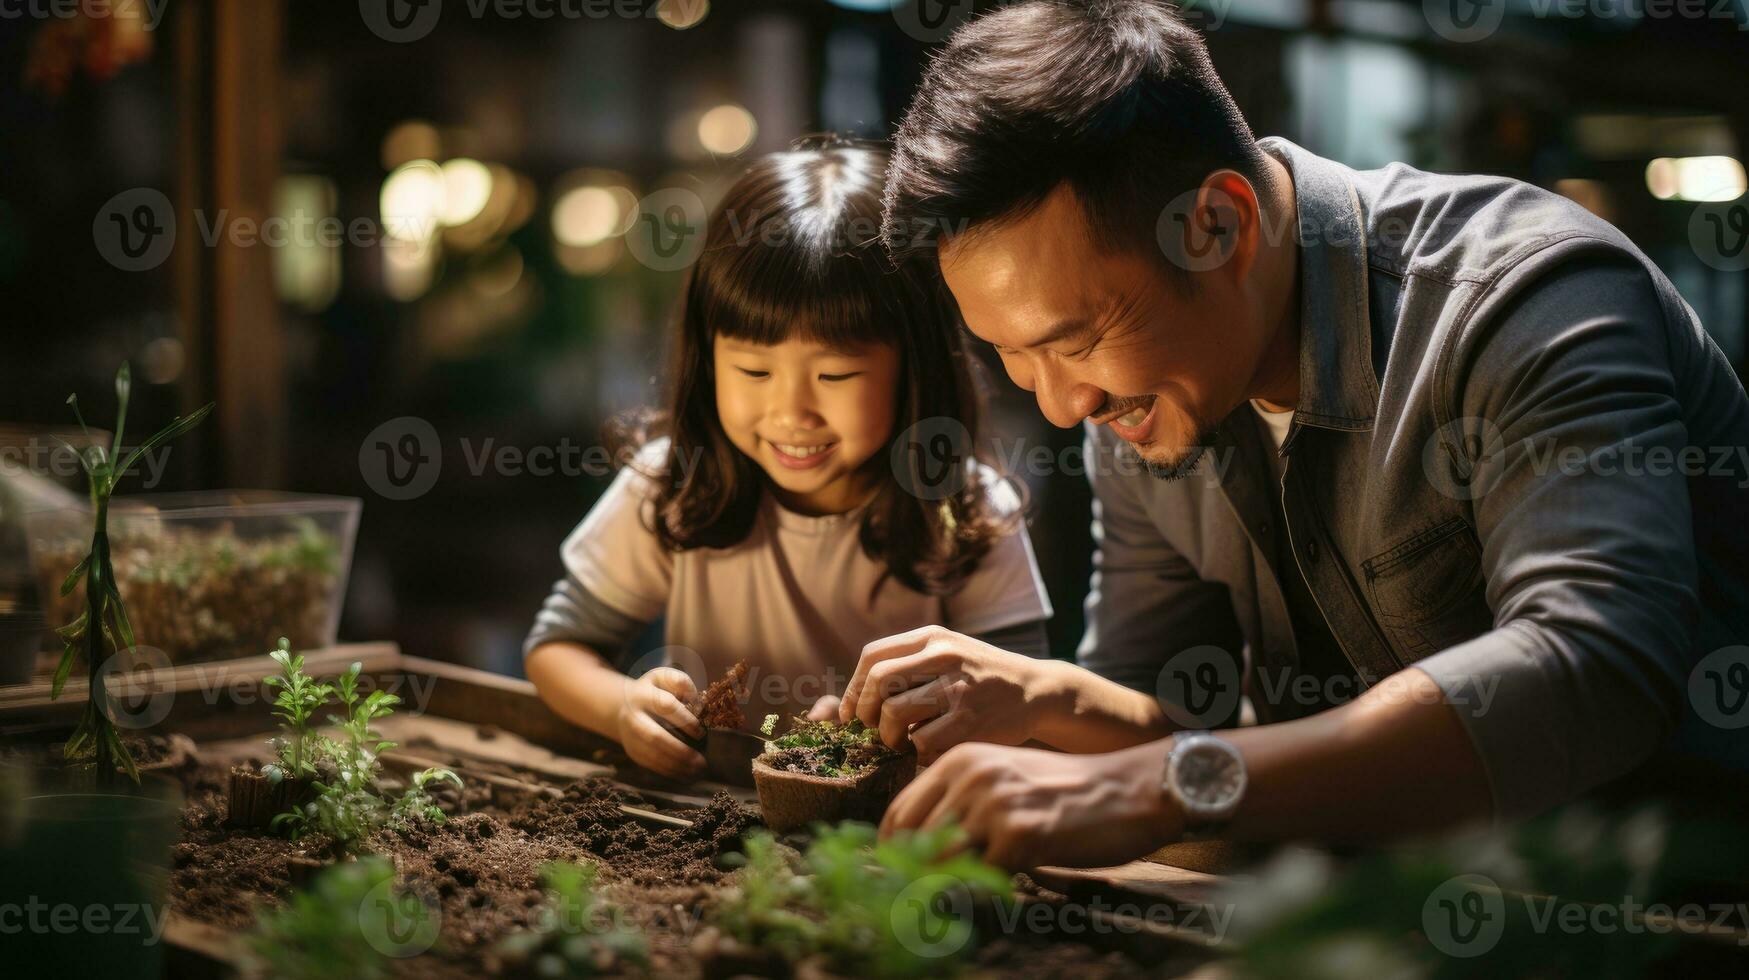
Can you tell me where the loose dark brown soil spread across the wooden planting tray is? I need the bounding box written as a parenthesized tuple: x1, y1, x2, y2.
(157, 738, 1168, 980)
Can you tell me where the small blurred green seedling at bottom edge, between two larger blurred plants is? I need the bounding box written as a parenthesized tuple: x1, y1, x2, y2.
(497, 861, 649, 977)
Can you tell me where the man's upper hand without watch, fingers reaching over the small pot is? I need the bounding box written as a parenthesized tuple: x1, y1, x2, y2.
(838, 627, 1053, 763)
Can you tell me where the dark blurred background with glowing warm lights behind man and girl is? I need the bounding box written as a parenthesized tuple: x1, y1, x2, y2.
(0, 0, 1749, 672)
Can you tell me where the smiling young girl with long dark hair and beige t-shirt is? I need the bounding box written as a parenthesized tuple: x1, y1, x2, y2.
(525, 144, 1051, 775)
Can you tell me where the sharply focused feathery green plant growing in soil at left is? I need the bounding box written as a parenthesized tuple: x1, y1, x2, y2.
(266, 651, 462, 851)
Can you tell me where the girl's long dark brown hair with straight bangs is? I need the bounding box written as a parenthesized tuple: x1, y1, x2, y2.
(619, 137, 1018, 595)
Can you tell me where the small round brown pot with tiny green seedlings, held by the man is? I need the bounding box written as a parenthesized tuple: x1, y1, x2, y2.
(752, 714, 916, 833)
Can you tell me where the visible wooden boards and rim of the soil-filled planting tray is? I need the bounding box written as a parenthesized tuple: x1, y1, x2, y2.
(0, 642, 1221, 977)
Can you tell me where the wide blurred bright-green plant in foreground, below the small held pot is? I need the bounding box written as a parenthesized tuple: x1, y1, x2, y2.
(712, 823, 1009, 978)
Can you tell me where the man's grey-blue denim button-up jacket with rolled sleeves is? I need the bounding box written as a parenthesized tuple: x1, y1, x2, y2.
(1081, 138, 1749, 817)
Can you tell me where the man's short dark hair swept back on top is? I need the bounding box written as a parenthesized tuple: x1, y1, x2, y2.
(881, 0, 1268, 266)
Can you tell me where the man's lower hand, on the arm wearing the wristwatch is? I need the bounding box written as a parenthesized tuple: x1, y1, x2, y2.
(880, 742, 1184, 872)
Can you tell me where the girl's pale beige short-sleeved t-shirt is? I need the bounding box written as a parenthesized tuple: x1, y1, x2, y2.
(561, 441, 1051, 726)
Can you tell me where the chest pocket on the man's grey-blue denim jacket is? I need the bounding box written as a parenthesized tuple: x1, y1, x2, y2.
(1361, 518, 1494, 663)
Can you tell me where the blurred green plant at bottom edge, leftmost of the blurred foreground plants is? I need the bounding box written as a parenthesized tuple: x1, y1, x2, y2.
(248, 858, 437, 980)
